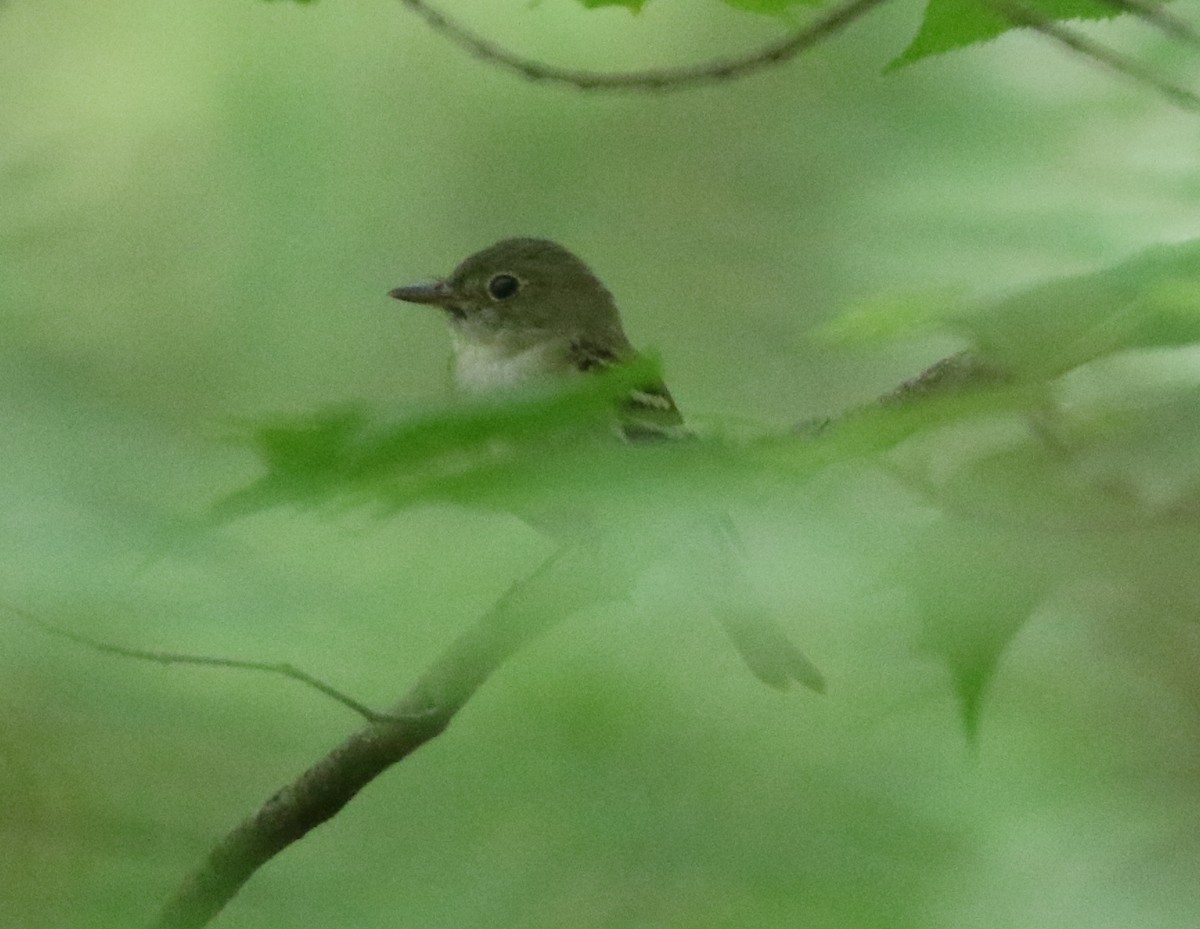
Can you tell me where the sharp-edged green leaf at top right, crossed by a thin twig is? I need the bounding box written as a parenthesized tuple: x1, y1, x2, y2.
(889, 0, 1121, 67)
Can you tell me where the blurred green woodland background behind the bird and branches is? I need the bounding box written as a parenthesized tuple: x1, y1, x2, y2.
(0, 0, 1200, 929)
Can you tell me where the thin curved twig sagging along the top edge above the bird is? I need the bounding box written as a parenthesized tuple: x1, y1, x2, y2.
(401, 0, 886, 90)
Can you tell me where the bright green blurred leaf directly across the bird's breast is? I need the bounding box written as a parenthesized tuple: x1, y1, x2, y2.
(208, 359, 676, 519)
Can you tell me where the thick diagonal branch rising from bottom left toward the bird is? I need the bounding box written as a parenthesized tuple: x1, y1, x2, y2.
(154, 546, 628, 929)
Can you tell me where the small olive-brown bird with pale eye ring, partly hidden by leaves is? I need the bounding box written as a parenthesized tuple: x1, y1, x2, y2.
(390, 239, 824, 691)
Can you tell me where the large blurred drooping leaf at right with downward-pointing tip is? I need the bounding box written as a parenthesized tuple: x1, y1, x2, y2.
(887, 347, 1200, 732)
